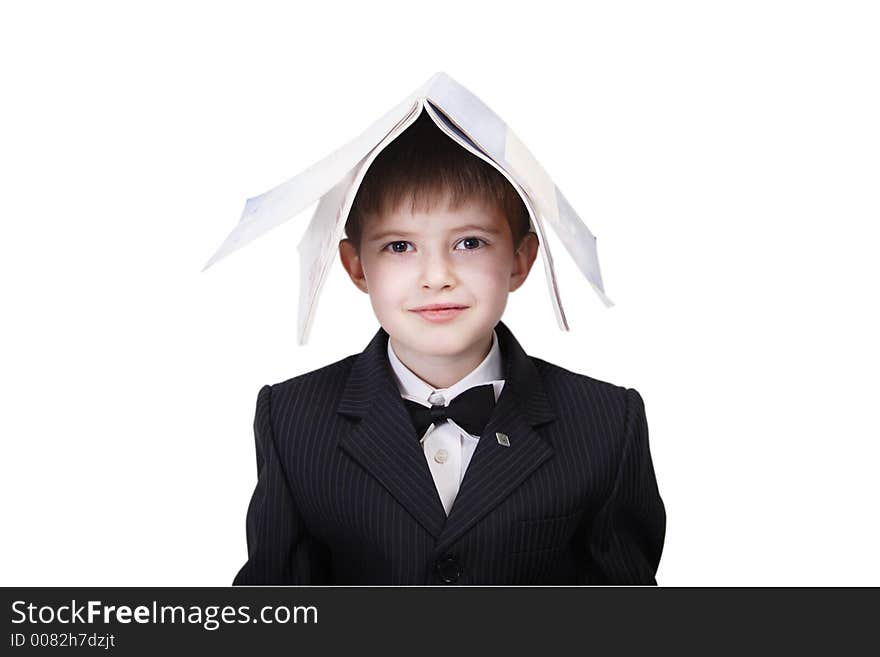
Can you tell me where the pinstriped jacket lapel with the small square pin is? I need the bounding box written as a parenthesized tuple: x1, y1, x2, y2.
(437, 322, 554, 552)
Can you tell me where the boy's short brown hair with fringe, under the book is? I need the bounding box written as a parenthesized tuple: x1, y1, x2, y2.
(345, 111, 529, 251)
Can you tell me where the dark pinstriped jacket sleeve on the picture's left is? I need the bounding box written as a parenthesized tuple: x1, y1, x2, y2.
(233, 385, 318, 586)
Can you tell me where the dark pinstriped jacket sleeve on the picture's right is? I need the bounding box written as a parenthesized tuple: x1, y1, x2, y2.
(581, 389, 666, 584)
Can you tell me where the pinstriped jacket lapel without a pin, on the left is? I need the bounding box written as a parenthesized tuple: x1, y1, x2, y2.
(337, 328, 446, 538)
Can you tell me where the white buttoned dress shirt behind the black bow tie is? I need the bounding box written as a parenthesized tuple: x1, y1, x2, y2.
(388, 331, 504, 515)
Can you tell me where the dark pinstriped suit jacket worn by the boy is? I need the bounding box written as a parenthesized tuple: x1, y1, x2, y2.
(233, 322, 666, 584)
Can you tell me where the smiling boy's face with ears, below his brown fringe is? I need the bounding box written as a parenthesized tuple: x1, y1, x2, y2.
(339, 196, 538, 366)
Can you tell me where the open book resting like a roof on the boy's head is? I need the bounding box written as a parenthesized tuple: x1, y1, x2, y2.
(202, 73, 613, 344)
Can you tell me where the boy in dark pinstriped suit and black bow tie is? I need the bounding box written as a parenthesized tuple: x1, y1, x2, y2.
(234, 114, 665, 584)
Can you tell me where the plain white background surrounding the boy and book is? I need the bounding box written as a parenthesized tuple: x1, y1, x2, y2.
(0, 0, 880, 586)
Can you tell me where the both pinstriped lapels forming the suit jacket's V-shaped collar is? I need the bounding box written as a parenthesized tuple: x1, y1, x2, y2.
(337, 321, 554, 553)
